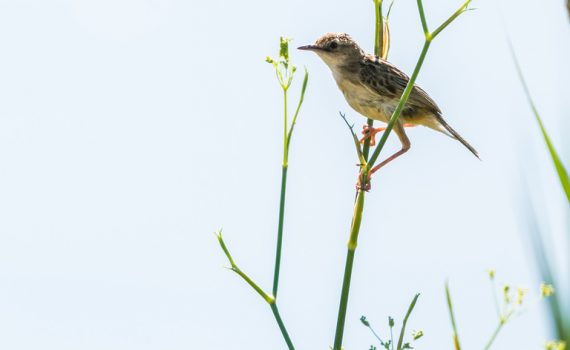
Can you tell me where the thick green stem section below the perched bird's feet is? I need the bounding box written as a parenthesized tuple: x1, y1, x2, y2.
(333, 190, 366, 350)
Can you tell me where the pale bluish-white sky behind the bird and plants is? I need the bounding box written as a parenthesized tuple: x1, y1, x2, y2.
(0, 0, 570, 350)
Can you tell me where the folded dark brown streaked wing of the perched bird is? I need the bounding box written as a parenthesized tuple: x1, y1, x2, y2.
(359, 56, 441, 114)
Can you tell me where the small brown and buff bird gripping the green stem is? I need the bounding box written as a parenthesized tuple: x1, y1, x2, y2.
(298, 33, 479, 189)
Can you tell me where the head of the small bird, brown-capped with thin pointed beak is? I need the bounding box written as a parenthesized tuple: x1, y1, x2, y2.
(298, 33, 365, 68)
